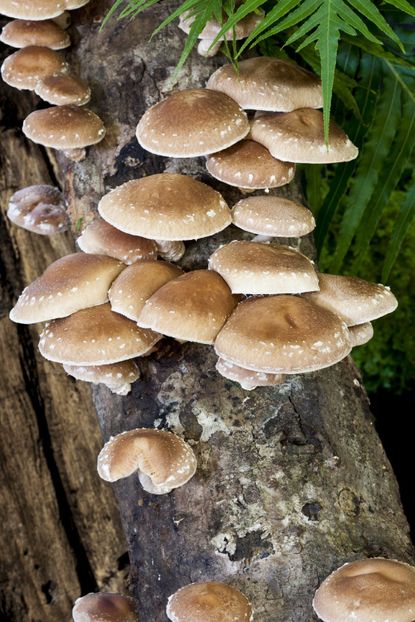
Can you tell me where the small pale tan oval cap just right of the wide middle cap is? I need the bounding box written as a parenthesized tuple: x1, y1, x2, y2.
(232, 195, 316, 238)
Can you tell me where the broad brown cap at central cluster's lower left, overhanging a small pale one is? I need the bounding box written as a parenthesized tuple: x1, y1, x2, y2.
(39, 304, 161, 366)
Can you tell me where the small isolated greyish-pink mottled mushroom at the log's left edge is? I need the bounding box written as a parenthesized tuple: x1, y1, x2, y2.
(7, 184, 69, 235)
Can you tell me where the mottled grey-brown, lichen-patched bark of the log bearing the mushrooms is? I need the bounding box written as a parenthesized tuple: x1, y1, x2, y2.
(0, 1, 413, 622)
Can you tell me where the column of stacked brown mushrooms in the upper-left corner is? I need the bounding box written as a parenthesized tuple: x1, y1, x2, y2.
(0, 0, 105, 161)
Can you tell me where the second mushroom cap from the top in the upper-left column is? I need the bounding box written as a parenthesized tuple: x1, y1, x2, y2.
(0, 19, 71, 50)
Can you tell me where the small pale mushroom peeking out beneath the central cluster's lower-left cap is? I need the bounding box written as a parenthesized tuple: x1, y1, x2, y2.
(63, 360, 140, 395)
